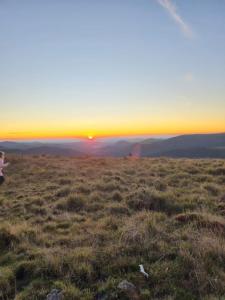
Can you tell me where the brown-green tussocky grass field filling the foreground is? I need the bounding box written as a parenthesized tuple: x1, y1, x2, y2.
(0, 156, 225, 300)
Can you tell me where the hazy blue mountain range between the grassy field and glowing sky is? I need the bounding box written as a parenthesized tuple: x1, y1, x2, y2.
(0, 133, 225, 158)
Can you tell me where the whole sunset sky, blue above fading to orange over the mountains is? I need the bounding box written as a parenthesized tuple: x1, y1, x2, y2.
(0, 0, 225, 139)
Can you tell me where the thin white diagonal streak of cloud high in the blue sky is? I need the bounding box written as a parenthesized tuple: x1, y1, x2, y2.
(157, 0, 193, 38)
